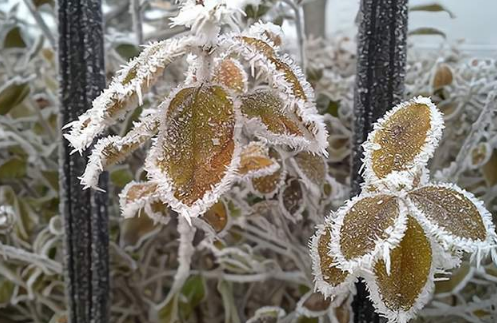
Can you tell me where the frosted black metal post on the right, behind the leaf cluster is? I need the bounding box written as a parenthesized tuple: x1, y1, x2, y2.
(352, 0, 407, 323)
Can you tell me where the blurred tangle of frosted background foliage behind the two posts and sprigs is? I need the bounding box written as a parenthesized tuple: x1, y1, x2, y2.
(0, 0, 497, 323)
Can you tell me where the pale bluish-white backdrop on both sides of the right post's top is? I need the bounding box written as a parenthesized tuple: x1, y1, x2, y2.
(326, 0, 497, 56)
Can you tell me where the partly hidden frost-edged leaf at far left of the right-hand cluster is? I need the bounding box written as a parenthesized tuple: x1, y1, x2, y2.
(309, 220, 353, 298)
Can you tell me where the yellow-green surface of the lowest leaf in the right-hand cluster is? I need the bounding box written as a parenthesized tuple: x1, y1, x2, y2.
(374, 217, 433, 312)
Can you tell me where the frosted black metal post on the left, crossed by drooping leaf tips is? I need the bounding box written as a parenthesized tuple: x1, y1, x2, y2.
(58, 0, 109, 323)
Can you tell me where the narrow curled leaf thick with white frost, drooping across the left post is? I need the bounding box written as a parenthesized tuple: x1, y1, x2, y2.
(64, 37, 192, 151)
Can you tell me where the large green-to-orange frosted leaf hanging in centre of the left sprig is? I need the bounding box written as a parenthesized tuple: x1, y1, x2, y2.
(147, 85, 239, 217)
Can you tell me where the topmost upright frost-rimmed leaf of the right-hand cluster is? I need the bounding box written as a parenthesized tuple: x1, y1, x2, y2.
(364, 97, 443, 188)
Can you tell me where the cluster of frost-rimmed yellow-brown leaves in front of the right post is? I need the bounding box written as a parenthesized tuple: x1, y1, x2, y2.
(311, 97, 497, 323)
